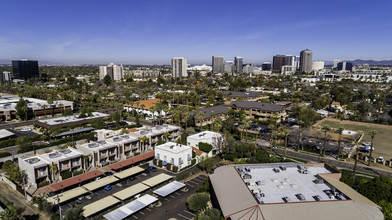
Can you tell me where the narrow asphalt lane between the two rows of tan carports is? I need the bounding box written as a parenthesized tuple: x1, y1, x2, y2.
(61, 169, 165, 211)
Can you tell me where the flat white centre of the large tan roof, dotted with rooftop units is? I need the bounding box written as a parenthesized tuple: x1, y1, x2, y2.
(236, 164, 347, 203)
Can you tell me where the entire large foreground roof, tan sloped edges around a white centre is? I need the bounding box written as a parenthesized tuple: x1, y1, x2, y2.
(210, 164, 383, 220)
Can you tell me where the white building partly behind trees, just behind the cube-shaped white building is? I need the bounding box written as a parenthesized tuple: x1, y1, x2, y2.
(186, 131, 224, 156)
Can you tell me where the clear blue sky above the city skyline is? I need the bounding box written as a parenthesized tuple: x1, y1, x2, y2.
(0, 0, 392, 64)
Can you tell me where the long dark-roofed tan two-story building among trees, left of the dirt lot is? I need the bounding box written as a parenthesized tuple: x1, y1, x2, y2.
(230, 101, 287, 123)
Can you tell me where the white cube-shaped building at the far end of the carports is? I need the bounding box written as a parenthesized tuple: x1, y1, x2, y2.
(155, 142, 192, 169)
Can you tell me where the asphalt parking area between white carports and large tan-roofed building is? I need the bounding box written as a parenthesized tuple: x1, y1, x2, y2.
(126, 175, 207, 220)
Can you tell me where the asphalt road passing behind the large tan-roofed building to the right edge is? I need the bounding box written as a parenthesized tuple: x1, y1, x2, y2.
(257, 139, 392, 178)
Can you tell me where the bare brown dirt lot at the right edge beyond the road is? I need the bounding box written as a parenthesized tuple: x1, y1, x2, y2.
(316, 118, 392, 160)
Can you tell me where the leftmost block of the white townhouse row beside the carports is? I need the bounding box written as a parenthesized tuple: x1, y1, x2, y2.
(18, 148, 83, 188)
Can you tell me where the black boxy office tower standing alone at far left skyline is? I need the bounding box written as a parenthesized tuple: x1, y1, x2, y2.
(12, 59, 39, 80)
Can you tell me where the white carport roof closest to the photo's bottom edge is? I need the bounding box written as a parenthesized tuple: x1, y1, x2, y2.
(103, 194, 158, 220)
